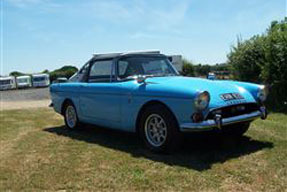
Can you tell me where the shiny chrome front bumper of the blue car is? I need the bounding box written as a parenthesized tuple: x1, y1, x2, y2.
(180, 111, 262, 132)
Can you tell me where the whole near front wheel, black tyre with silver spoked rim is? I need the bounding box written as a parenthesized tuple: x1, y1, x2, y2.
(139, 104, 181, 153)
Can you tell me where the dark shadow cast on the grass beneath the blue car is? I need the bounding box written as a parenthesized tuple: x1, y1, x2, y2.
(44, 125, 273, 171)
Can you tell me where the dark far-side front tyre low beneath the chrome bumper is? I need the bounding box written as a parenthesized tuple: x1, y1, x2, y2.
(222, 122, 250, 137)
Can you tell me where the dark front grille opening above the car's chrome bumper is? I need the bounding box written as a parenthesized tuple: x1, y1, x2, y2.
(206, 103, 259, 119)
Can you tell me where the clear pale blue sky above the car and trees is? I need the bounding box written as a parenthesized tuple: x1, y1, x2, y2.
(0, 0, 287, 74)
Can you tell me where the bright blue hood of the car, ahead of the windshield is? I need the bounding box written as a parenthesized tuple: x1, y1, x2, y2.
(136, 76, 256, 107)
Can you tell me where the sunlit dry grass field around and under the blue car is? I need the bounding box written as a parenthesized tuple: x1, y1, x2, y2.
(0, 108, 287, 192)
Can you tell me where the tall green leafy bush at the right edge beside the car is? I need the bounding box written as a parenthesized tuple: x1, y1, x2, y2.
(228, 18, 287, 110)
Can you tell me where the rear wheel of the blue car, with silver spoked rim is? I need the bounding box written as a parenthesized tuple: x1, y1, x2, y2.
(64, 102, 80, 129)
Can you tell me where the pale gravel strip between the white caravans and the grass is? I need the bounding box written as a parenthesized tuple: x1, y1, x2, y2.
(0, 88, 51, 111)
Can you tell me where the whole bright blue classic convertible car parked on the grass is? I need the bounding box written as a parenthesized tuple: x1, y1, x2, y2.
(50, 52, 267, 152)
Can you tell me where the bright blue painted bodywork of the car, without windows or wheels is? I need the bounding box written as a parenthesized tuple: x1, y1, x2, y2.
(50, 76, 259, 132)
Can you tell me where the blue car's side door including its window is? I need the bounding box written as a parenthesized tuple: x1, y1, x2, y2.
(80, 59, 121, 126)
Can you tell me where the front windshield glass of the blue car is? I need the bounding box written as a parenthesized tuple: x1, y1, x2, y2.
(118, 57, 178, 79)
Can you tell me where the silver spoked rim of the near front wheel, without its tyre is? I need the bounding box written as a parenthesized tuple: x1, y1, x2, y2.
(144, 114, 167, 147)
